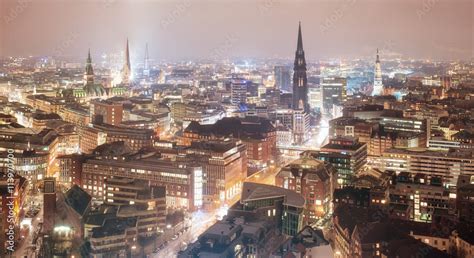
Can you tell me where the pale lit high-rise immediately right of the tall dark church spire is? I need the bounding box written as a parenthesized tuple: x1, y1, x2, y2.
(321, 77, 347, 114)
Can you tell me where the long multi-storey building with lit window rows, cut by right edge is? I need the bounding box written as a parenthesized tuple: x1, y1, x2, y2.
(382, 149, 474, 187)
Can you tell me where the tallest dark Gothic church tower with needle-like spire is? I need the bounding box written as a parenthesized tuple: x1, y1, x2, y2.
(293, 22, 309, 111)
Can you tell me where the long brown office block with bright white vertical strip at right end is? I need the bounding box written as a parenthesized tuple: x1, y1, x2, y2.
(82, 152, 203, 211)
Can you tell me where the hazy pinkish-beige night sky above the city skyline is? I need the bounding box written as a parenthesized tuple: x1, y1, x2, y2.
(0, 0, 474, 60)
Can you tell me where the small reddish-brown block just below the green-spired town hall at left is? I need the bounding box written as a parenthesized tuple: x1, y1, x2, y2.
(90, 100, 123, 125)
